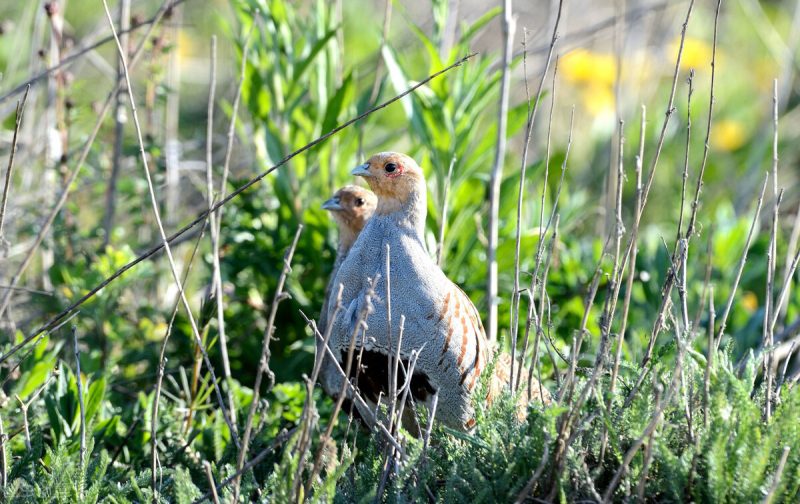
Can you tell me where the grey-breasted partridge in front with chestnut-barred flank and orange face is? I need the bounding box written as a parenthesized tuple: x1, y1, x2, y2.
(328, 152, 489, 429)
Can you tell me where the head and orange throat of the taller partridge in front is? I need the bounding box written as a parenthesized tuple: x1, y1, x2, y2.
(351, 152, 427, 214)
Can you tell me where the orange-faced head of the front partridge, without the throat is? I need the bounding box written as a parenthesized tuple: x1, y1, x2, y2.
(352, 152, 425, 202)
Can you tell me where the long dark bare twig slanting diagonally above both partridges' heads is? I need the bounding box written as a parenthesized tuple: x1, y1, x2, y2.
(0, 53, 477, 364)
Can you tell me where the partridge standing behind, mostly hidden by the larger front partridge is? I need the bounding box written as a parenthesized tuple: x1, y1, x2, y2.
(316, 185, 378, 396)
